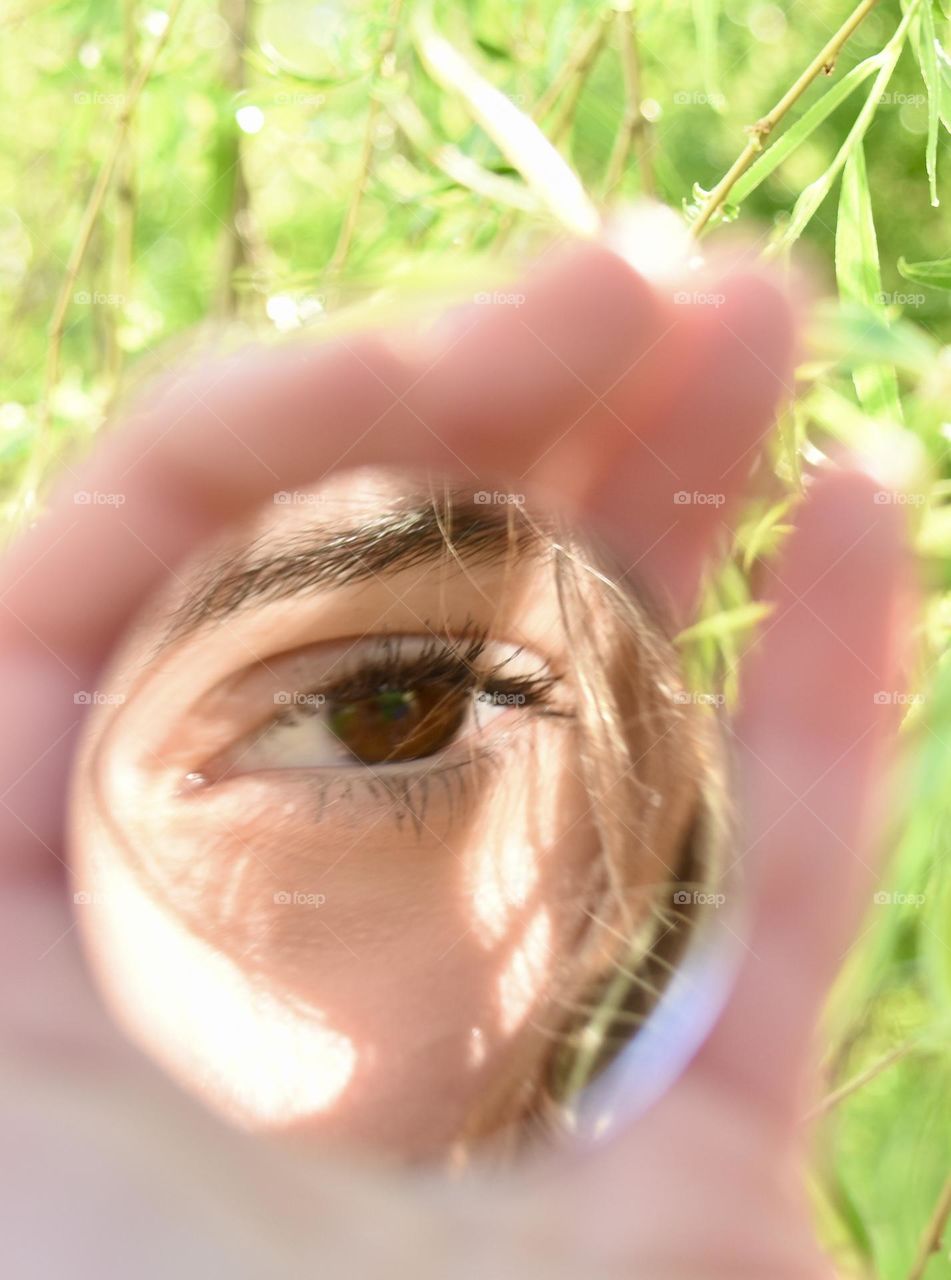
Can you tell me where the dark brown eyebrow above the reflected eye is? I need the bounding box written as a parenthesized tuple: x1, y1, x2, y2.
(161, 495, 543, 648)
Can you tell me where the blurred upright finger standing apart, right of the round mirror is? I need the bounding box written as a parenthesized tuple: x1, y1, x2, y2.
(695, 474, 911, 1124)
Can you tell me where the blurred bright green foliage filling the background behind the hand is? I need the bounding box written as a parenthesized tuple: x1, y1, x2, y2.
(0, 0, 951, 1280)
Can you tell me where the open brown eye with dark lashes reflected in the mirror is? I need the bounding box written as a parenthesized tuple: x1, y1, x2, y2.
(202, 636, 566, 781)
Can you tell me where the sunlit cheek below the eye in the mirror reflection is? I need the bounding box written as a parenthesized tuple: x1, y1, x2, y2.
(72, 735, 609, 1155)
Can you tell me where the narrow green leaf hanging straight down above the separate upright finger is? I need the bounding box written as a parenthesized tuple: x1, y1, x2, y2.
(836, 142, 904, 422)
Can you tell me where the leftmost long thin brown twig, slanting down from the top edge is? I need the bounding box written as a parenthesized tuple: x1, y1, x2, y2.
(23, 0, 184, 500)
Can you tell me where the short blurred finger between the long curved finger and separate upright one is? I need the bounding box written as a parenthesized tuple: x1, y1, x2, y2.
(590, 268, 795, 625)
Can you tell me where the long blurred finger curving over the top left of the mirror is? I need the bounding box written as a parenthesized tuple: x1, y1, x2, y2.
(0, 246, 651, 874)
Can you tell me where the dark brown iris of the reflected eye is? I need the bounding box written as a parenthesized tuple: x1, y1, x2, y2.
(329, 681, 471, 764)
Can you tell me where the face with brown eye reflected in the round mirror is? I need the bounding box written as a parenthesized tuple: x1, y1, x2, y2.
(72, 471, 706, 1160)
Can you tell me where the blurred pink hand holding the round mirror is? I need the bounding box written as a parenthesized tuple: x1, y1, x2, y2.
(0, 243, 911, 1280)
